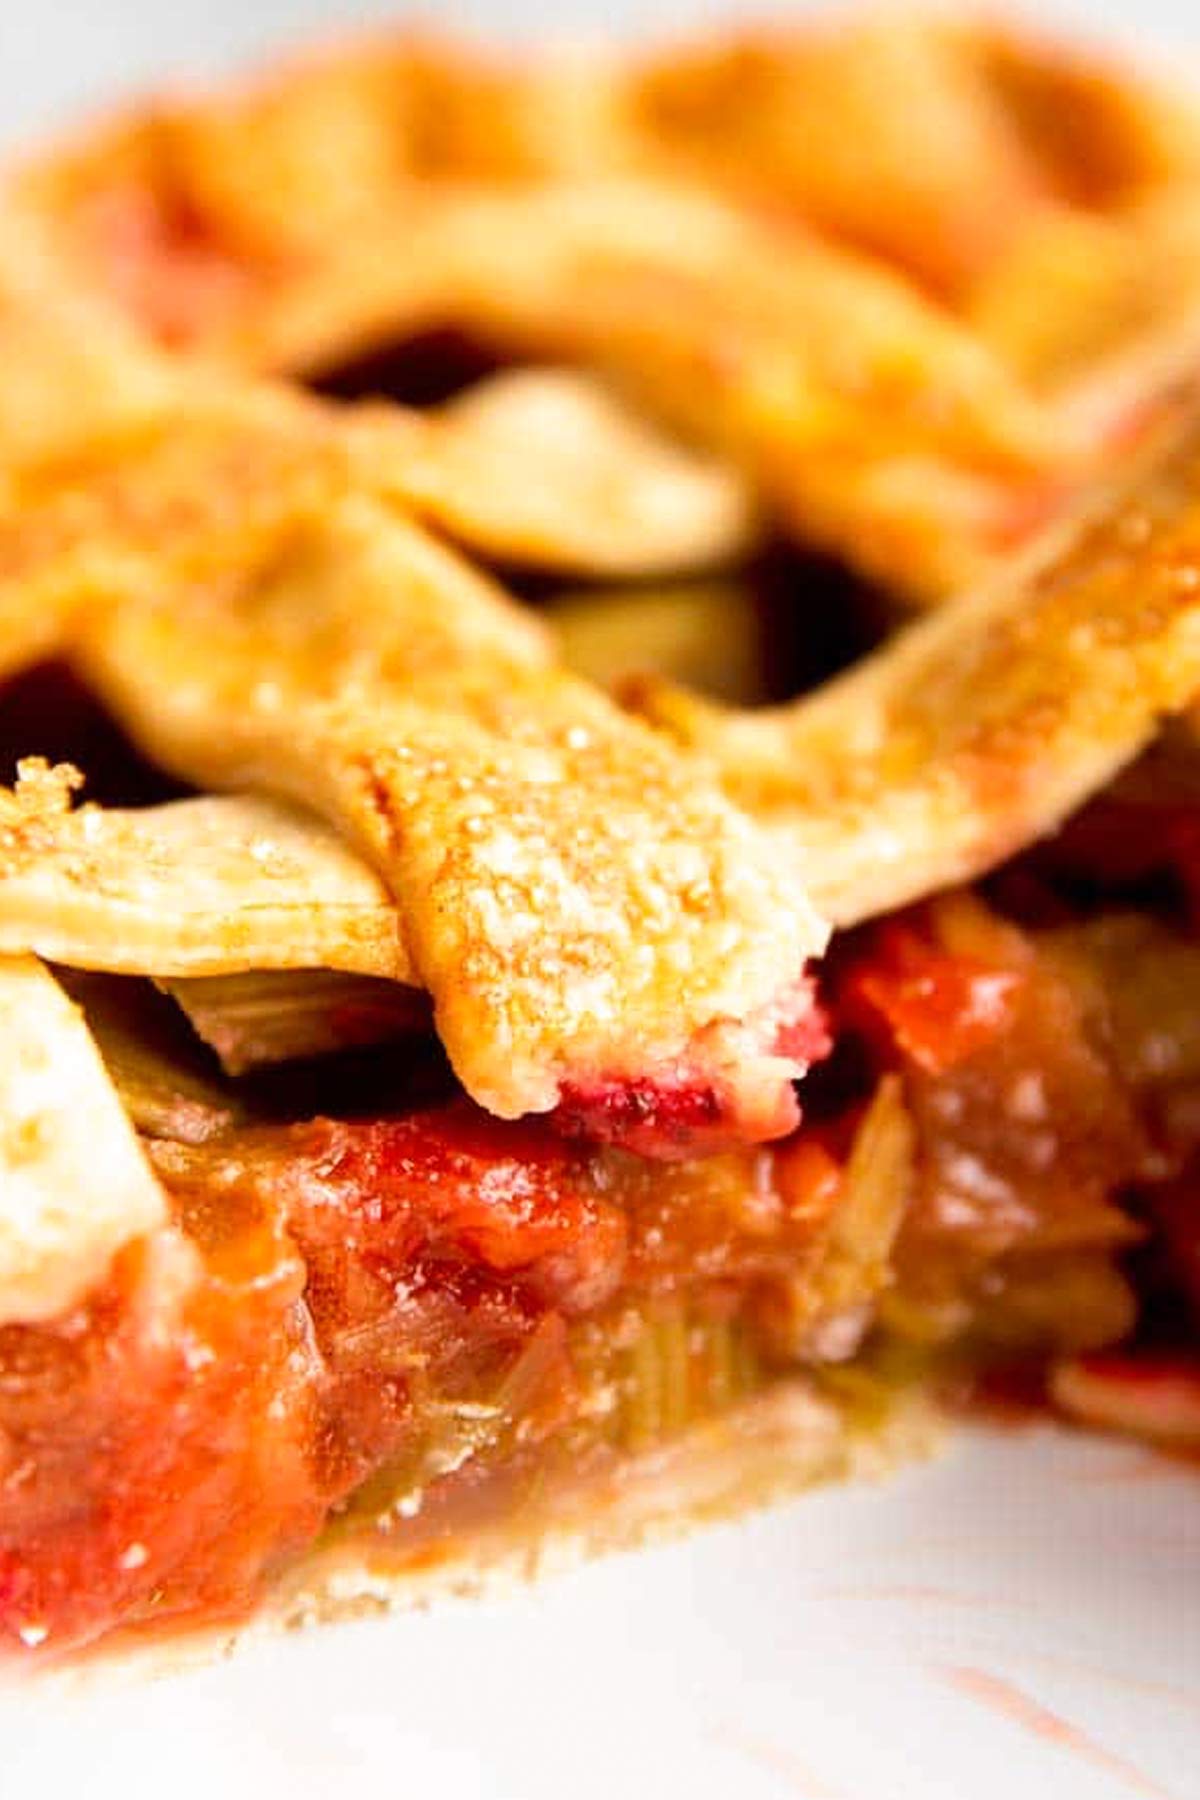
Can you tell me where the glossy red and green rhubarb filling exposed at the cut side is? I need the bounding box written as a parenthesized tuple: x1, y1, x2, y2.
(0, 801, 1200, 1651)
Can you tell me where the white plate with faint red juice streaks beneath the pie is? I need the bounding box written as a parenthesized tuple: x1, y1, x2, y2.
(0, 1427, 1200, 1800)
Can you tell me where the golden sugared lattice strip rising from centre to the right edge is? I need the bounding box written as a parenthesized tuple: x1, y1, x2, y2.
(639, 389, 1200, 925)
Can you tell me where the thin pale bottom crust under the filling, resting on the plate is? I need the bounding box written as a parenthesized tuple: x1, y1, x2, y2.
(42, 1377, 945, 1690)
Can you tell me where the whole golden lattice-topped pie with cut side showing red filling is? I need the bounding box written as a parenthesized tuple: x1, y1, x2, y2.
(0, 20, 1200, 1656)
